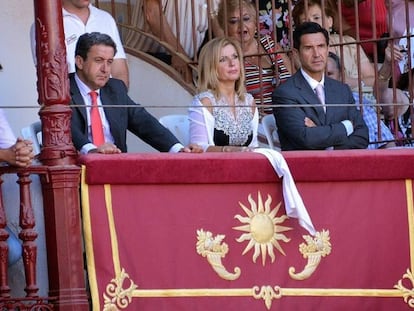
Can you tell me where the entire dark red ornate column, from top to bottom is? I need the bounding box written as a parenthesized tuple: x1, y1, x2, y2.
(33, 0, 89, 311)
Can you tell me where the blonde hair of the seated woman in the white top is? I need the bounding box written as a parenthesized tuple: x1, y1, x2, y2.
(197, 37, 246, 100)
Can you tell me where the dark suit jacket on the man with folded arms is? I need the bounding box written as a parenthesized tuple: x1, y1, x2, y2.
(273, 70, 369, 150)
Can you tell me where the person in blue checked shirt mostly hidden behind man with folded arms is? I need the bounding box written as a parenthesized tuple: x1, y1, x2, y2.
(326, 52, 395, 149)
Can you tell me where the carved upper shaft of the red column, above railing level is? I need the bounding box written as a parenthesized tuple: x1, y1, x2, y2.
(34, 0, 76, 165)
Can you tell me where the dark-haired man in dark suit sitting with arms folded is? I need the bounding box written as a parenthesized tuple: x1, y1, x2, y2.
(273, 22, 368, 150)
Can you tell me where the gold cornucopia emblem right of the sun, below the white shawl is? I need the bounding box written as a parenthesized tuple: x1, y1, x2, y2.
(289, 230, 332, 280)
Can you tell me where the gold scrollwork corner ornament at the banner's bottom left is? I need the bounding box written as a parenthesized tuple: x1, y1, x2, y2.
(103, 268, 138, 311)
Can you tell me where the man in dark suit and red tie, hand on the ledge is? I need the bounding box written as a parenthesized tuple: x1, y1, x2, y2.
(70, 32, 202, 154)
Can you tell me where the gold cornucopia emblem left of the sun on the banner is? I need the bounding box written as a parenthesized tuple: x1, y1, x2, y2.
(196, 229, 241, 281)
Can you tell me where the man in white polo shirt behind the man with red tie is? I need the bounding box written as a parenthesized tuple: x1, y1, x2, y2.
(31, 0, 129, 87)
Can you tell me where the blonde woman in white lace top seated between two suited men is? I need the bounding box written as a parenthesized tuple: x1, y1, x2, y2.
(189, 37, 259, 152)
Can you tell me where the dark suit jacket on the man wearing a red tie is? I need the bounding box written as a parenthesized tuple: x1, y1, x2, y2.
(69, 74, 179, 152)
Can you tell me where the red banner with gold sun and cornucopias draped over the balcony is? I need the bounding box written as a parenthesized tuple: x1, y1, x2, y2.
(81, 150, 414, 311)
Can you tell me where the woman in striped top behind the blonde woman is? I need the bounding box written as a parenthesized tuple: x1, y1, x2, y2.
(217, 0, 292, 116)
